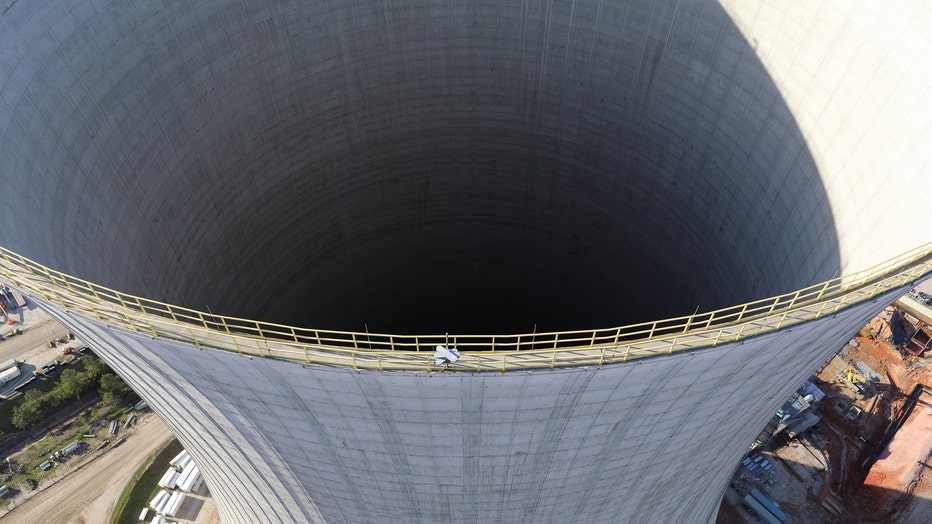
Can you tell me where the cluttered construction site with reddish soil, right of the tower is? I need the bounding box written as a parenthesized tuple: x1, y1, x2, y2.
(717, 285, 932, 524)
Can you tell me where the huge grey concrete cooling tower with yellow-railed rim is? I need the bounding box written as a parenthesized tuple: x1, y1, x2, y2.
(0, 0, 932, 523)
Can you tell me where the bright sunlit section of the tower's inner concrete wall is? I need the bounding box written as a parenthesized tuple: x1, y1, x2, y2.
(722, 0, 932, 274)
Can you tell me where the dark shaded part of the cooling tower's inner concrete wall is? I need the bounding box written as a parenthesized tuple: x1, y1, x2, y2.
(7, 1, 908, 333)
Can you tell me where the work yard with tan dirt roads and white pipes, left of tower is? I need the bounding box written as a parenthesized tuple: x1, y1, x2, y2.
(0, 296, 218, 524)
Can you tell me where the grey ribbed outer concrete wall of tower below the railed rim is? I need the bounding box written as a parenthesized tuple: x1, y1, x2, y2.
(41, 293, 896, 523)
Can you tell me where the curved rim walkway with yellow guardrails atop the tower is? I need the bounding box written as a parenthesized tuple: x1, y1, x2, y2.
(0, 242, 932, 371)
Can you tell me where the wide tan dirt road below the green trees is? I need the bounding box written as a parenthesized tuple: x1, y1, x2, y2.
(0, 413, 173, 524)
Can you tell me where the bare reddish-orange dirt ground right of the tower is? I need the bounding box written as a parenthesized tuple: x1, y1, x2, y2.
(718, 320, 932, 524)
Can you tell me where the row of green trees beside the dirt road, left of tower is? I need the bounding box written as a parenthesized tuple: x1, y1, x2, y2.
(11, 355, 132, 430)
